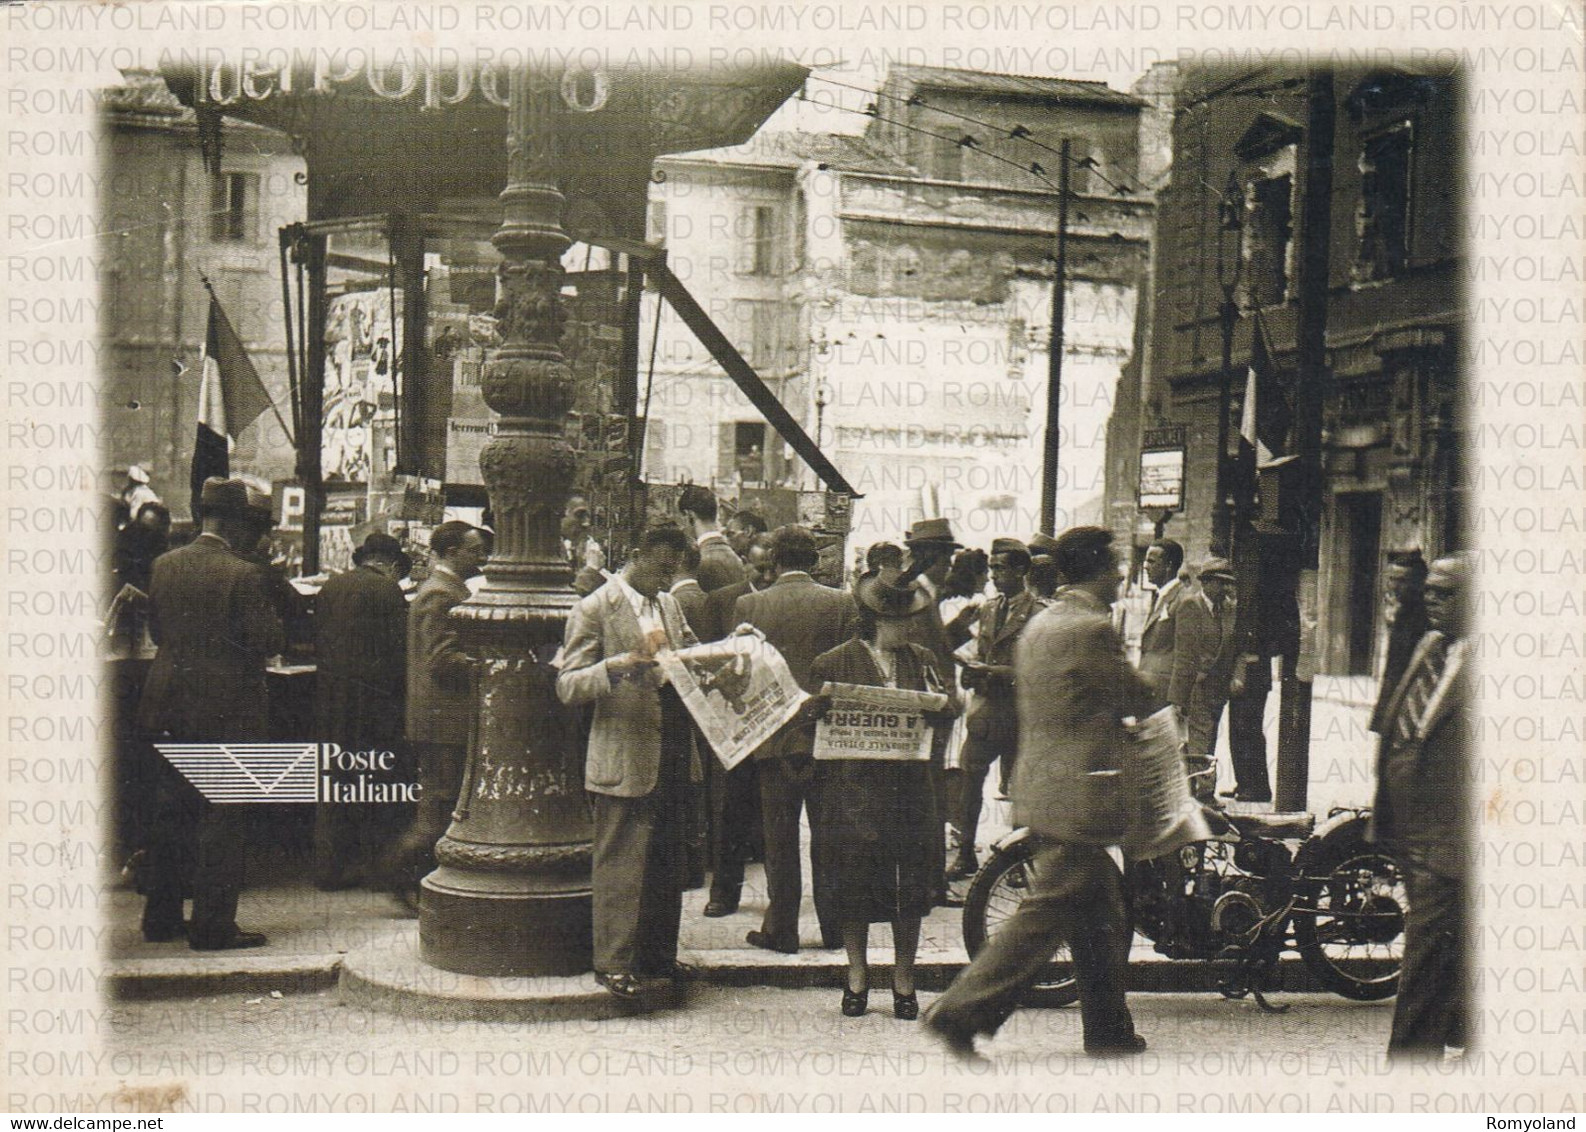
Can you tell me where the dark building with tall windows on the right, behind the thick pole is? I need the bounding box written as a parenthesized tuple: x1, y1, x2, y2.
(1107, 68, 1464, 675)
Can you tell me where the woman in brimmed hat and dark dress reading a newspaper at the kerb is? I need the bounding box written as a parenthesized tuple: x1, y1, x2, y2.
(810, 569, 953, 1019)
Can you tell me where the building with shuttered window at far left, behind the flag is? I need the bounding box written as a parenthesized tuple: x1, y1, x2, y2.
(100, 75, 308, 518)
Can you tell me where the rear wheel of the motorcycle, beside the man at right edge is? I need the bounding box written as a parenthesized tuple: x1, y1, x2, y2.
(1294, 824, 1410, 1002)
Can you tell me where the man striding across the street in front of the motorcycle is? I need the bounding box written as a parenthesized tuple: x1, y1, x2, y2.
(925, 526, 1151, 1057)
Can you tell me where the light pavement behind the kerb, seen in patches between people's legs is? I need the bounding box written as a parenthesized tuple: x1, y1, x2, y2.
(108, 680, 1373, 997)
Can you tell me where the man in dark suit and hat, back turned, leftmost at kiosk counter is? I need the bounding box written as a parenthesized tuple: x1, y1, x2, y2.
(138, 477, 285, 951)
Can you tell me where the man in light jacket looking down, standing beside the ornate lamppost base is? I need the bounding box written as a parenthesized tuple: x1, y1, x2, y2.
(557, 526, 699, 999)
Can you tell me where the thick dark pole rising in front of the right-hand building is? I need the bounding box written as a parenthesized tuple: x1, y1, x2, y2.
(1275, 67, 1335, 813)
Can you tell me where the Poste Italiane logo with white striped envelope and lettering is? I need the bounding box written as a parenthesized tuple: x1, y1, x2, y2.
(154, 744, 420, 805)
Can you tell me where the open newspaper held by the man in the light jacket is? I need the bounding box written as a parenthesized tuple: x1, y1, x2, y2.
(655, 633, 809, 771)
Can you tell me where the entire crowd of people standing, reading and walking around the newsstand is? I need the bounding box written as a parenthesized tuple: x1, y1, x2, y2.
(123, 479, 1464, 1056)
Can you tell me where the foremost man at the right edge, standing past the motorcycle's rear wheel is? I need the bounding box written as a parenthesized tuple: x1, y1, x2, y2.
(1372, 556, 1470, 1056)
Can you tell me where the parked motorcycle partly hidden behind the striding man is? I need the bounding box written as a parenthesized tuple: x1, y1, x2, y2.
(963, 809, 1408, 1012)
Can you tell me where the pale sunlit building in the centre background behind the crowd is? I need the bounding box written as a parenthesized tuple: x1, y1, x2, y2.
(639, 67, 1153, 545)
